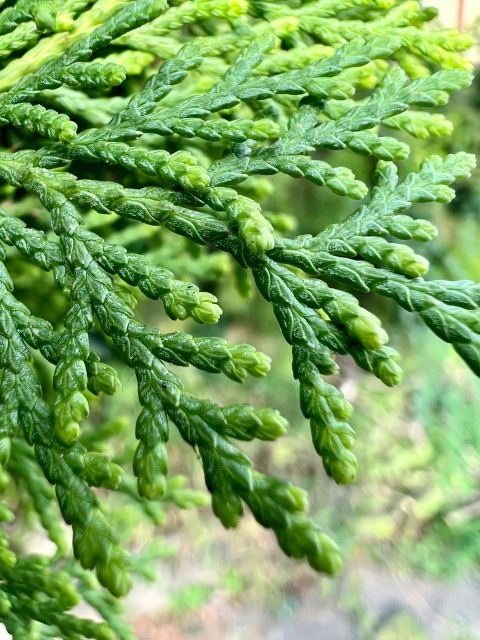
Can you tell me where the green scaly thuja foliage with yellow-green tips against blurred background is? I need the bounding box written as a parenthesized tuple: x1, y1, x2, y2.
(0, 0, 480, 639)
